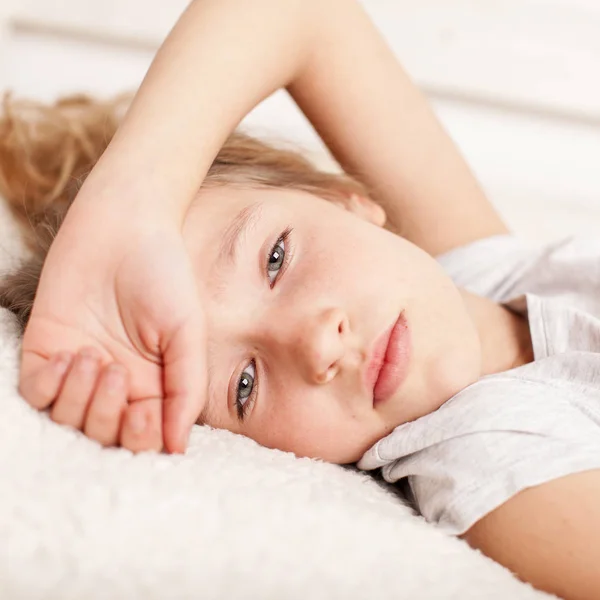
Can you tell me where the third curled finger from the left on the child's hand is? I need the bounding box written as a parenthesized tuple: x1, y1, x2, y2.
(83, 363, 128, 446)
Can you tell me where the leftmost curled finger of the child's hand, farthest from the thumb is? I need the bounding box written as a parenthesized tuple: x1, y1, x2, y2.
(19, 352, 73, 410)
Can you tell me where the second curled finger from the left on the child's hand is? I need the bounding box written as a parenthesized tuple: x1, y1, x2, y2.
(50, 347, 100, 429)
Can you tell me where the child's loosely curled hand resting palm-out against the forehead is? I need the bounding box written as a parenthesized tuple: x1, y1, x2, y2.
(19, 197, 206, 452)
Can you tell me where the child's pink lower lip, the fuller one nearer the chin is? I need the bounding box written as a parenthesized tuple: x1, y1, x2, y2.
(373, 312, 410, 404)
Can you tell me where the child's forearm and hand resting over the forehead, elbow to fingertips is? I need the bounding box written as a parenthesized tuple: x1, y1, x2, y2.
(19, 0, 328, 452)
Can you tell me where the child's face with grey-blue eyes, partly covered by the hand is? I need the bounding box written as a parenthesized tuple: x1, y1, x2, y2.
(184, 187, 481, 463)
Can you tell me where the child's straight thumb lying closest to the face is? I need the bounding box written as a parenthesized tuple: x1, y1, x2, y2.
(163, 313, 207, 452)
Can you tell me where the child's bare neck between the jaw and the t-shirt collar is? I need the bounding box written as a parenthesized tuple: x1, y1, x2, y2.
(460, 290, 533, 376)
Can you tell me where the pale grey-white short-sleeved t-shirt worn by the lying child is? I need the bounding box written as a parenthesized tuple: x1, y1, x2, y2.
(358, 235, 600, 535)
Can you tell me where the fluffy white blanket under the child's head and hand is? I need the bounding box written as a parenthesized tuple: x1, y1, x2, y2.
(0, 203, 548, 600)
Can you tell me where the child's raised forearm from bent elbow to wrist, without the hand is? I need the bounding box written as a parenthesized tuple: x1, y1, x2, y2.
(82, 0, 323, 221)
